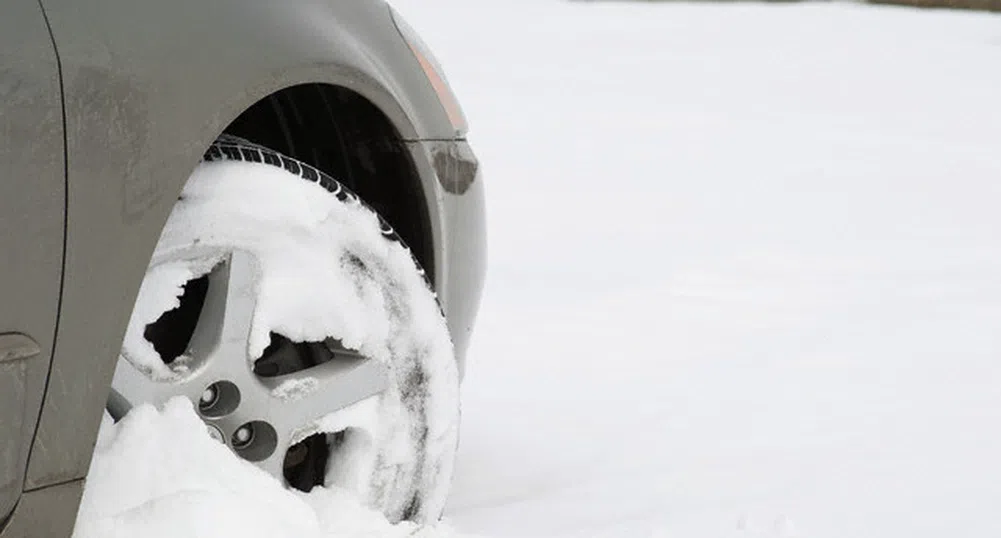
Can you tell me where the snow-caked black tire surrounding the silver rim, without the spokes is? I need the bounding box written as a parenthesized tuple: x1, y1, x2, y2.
(123, 138, 458, 521)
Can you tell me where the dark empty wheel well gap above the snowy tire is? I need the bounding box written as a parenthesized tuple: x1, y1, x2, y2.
(224, 84, 435, 286)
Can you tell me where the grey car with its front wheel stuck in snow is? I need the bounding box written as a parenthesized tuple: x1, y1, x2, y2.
(0, 0, 485, 538)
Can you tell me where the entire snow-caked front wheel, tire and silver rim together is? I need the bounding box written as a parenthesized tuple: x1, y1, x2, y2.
(113, 137, 458, 520)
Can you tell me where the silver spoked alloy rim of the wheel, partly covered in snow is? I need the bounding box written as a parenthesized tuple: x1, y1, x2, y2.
(113, 248, 389, 490)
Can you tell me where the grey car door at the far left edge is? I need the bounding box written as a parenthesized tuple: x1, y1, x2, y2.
(0, 0, 66, 527)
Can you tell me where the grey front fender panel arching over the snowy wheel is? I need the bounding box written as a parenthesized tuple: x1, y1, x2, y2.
(25, 0, 482, 502)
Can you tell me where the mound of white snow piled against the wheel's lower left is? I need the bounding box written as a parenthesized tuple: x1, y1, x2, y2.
(74, 398, 464, 538)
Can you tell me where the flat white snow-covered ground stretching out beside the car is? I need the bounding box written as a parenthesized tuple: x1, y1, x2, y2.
(72, 0, 1001, 538)
